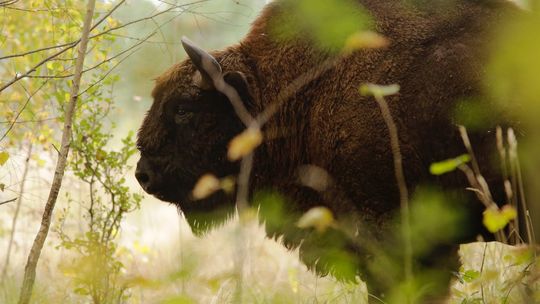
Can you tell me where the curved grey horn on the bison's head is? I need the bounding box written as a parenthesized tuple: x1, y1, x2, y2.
(182, 36, 222, 89)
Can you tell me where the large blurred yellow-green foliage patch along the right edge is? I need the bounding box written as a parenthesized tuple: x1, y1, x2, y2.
(485, 0, 540, 243)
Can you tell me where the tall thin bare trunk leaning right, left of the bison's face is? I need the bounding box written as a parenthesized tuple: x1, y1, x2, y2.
(19, 0, 96, 304)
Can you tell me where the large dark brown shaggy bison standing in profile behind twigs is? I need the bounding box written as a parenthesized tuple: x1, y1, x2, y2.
(136, 0, 516, 300)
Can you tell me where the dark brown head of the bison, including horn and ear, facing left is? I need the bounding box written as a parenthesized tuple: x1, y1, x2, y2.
(135, 38, 251, 232)
